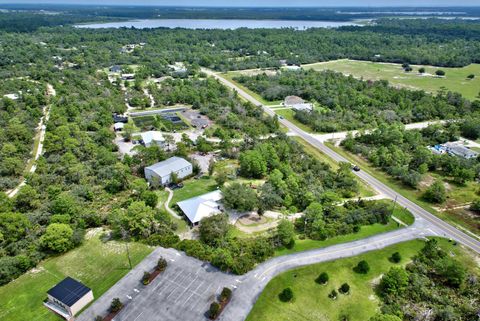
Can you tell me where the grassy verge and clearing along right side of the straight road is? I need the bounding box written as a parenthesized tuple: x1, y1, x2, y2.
(326, 142, 480, 238)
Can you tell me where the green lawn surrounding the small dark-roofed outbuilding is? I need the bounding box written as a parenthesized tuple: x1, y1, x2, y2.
(0, 229, 153, 321)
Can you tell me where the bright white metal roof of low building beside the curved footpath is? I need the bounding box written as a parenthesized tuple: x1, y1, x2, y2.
(177, 190, 222, 225)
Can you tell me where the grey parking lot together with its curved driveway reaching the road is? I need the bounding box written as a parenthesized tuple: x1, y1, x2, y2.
(76, 222, 433, 321)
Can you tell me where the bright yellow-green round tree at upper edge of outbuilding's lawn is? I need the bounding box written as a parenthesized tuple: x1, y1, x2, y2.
(40, 223, 73, 253)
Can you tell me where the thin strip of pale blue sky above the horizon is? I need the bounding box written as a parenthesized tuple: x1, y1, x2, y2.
(0, 0, 480, 7)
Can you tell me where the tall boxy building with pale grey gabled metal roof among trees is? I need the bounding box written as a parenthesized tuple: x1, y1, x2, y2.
(145, 156, 193, 186)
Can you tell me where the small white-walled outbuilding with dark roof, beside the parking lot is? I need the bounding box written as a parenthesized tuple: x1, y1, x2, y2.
(43, 277, 93, 321)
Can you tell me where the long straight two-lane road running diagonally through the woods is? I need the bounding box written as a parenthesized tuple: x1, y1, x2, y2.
(202, 69, 480, 253)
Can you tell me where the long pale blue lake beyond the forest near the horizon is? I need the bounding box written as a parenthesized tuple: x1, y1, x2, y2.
(75, 19, 356, 29)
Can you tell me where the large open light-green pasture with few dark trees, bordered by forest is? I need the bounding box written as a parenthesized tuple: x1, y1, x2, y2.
(303, 59, 480, 100)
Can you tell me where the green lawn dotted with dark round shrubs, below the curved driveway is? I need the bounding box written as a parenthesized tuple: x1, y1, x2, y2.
(247, 239, 476, 321)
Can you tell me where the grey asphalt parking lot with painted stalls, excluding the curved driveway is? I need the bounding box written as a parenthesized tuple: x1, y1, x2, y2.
(78, 248, 241, 321)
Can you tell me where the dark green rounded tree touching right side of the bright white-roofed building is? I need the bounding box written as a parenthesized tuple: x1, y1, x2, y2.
(222, 183, 258, 212)
